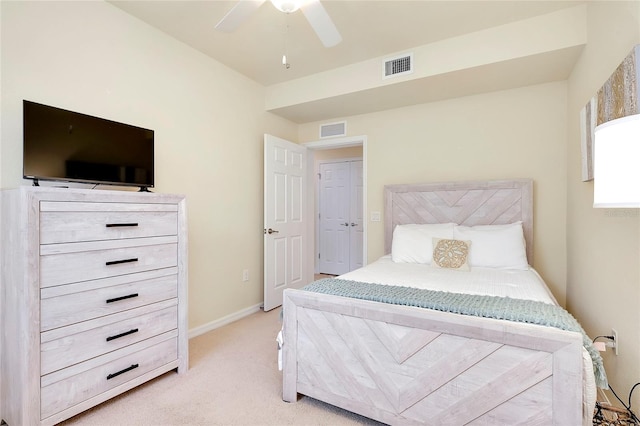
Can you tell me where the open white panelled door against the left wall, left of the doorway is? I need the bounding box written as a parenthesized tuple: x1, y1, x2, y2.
(264, 134, 307, 311)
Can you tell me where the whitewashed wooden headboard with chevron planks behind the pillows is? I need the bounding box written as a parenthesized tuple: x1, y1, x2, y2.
(384, 179, 533, 265)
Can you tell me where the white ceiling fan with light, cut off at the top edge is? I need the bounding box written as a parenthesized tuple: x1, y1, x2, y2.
(216, 0, 342, 47)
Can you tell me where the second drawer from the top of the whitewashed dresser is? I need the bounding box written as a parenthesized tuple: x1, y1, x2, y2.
(40, 237, 178, 288)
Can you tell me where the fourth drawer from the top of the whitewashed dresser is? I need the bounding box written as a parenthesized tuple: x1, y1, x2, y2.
(40, 299, 178, 375)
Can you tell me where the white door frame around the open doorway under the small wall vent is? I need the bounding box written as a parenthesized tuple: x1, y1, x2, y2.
(301, 135, 369, 276)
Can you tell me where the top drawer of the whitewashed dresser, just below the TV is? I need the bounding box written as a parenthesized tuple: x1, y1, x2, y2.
(40, 203, 178, 244)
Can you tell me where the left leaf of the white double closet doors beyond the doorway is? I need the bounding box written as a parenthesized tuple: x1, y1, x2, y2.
(318, 161, 351, 275)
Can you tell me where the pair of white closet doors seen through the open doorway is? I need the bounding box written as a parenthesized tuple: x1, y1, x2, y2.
(318, 160, 364, 275)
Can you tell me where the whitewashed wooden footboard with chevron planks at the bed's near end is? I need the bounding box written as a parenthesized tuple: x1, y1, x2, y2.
(282, 290, 583, 426)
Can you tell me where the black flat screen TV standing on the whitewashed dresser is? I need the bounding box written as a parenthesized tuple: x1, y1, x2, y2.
(23, 100, 154, 190)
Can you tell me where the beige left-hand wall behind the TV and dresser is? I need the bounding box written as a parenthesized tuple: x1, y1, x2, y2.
(0, 1, 297, 334)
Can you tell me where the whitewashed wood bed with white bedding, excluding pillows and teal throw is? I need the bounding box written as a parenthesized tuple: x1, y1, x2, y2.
(281, 179, 606, 426)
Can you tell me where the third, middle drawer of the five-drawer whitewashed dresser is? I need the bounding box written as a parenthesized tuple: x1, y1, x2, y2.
(40, 268, 178, 331)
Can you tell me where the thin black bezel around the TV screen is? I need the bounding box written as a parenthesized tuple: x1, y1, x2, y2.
(22, 99, 155, 191)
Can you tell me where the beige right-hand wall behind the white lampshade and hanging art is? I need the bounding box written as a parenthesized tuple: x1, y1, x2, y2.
(566, 1, 640, 413)
